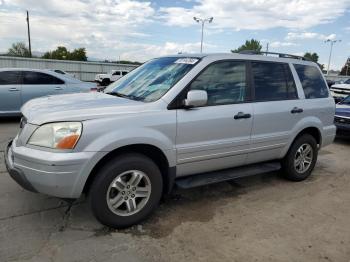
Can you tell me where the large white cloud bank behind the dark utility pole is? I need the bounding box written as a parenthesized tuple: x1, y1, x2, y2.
(0, 0, 156, 59)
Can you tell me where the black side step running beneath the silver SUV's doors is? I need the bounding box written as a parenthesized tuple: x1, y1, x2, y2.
(175, 162, 281, 189)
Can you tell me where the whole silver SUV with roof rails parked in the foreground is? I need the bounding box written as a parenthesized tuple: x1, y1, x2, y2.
(5, 54, 336, 228)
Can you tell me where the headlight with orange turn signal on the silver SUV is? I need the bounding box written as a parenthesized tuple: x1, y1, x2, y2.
(28, 122, 82, 149)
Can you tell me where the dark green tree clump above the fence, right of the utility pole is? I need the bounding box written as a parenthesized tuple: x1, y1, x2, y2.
(42, 46, 87, 61)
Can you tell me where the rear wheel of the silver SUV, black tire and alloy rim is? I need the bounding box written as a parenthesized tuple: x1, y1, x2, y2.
(282, 134, 318, 181)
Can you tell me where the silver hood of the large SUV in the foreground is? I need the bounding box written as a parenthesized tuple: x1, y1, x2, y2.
(21, 92, 156, 125)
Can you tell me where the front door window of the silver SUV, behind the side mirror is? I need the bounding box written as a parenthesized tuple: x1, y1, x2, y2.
(190, 62, 247, 106)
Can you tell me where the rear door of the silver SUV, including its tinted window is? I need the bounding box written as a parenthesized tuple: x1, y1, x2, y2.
(247, 61, 304, 163)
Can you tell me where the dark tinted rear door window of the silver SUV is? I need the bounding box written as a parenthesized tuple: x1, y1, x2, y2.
(252, 62, 298, 101)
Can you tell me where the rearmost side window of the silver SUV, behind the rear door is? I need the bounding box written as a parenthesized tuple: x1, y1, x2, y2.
(294, 64, 328, 99)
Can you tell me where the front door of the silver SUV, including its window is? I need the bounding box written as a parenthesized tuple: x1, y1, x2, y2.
(176, 61, 253, 176)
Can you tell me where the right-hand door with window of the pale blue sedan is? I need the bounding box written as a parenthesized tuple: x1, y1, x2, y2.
(22, 71, 66, 104)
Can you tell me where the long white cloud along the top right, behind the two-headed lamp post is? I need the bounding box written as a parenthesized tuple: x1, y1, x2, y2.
(159, 0, 350, 30)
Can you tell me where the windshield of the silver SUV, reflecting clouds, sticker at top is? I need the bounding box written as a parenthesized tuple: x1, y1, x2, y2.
(104, 57, 199, 102)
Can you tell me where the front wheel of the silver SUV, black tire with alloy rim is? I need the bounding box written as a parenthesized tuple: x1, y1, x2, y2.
(89, 153, 163, 229)
